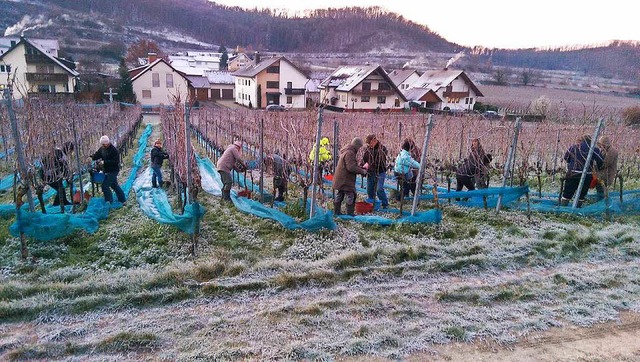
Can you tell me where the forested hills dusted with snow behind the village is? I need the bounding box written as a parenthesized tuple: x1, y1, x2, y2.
(0, 0, 640, 81)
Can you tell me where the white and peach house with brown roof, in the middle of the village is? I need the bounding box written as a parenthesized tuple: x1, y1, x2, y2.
(232, 53, 309, 108)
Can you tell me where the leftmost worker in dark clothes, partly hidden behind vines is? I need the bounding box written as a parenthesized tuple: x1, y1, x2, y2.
(40, 142, 74, 206)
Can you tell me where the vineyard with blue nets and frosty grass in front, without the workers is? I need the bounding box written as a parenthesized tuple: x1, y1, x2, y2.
(0, 92, 640, 360)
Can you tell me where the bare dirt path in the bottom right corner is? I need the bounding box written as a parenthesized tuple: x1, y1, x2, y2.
(420, 312, 640, 361)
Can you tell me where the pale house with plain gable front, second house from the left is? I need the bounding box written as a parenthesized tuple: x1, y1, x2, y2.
(129, 54, 191, 107)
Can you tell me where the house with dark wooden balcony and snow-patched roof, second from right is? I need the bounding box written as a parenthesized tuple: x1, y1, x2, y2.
(319, 65, 406, 112)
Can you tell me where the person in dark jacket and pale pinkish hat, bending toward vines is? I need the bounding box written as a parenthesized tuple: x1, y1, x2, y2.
(88, 136, 127, 205)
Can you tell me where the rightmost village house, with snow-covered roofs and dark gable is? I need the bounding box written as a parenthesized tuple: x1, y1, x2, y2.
(404, 68, 483, 111)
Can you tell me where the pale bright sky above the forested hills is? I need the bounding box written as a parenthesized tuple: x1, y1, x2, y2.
(214, 0, 640, 49)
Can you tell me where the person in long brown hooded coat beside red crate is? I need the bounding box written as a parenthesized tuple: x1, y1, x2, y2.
(333, 137, 367, 216)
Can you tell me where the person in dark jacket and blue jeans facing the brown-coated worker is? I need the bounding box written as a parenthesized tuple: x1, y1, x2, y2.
(362, 134, 389, 208)
